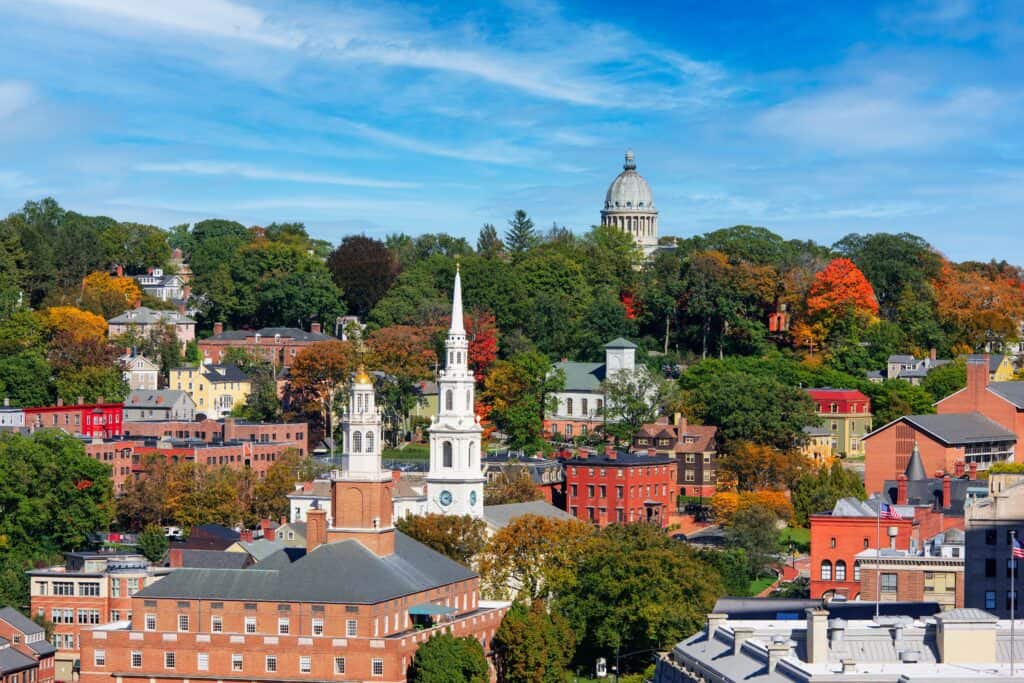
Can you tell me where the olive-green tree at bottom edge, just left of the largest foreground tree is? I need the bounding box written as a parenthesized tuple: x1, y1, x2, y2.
(490, 600, 575, 683)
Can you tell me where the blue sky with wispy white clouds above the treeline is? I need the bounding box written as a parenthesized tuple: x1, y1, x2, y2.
(0, 0, 1024, 263)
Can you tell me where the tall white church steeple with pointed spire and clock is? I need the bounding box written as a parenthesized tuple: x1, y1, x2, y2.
(427, 268, 483, 518)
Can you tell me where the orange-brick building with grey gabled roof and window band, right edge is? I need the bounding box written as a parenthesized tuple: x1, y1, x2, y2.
(864, 413, 1017, 494)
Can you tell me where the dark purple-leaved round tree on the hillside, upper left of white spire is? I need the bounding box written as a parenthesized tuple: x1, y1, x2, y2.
(327, 234, 398, 317)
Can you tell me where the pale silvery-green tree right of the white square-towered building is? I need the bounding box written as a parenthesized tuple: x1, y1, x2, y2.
(601, 366, 679, 441)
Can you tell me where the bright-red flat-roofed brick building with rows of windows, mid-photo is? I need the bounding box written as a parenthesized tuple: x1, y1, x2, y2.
(562, 446, 678, 527)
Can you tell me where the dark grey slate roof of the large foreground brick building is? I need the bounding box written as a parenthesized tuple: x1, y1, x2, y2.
(136, 531, 476, 604)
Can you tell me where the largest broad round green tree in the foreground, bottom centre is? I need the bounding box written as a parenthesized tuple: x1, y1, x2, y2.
(554, 524, 723, 669)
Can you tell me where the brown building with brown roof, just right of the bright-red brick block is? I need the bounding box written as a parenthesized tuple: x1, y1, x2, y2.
(631, 414, 719, 498)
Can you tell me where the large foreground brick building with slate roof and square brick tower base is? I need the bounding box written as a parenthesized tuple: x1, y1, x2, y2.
(74, 428, 508, 683)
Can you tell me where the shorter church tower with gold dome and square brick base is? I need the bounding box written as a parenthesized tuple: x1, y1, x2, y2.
(316, 366, 394, 555)
